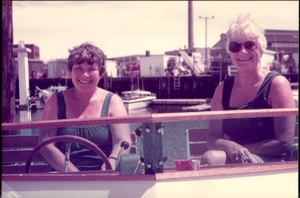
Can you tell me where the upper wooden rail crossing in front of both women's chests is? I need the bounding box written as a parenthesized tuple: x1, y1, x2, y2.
(1, 108, 298, 130)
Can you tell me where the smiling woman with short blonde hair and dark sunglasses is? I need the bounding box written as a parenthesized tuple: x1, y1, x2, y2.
(201, 14, 295, 165)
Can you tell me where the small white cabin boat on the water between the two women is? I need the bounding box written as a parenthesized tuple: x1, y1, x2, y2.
(122, 89, 156, 111)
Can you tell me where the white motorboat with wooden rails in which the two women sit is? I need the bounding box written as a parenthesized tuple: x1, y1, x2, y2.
(2, 108, 298, 198)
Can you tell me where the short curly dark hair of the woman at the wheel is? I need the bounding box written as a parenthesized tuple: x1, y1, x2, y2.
(68, 42, 106, 76)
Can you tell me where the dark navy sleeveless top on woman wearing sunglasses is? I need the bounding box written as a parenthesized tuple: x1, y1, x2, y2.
(222, 72, 279, 144)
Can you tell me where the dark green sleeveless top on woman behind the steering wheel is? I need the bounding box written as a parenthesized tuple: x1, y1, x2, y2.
(50, 92, 113, 170)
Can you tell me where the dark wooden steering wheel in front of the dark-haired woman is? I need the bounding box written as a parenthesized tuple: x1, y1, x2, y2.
(25, 135, 112, 173)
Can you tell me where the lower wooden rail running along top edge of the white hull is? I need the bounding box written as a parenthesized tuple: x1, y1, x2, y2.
(2, 162, 298, 182)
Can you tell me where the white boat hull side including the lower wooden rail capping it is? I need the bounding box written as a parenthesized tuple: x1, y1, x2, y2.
(2, 162, 298, 198)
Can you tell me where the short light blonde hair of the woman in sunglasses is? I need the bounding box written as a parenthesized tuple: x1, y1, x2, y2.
(226, 14, 267, 54)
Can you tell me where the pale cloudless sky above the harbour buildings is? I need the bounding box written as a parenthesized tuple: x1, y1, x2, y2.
(13, 1, 299, 61)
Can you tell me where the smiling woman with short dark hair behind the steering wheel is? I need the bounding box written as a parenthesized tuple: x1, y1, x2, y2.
(40, 42, 131, 172)
